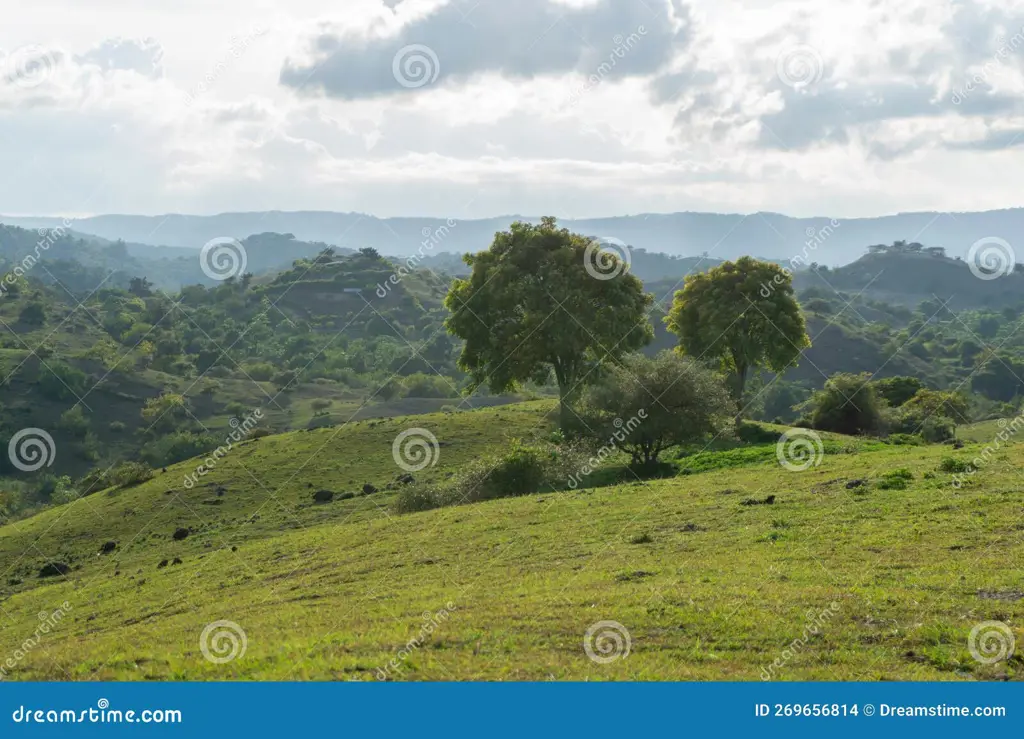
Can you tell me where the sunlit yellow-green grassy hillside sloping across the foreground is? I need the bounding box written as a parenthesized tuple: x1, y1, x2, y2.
(0, 402, 1024, 680)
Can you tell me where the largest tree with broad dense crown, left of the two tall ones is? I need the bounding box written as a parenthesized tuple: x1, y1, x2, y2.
(444, 217, 654, 428)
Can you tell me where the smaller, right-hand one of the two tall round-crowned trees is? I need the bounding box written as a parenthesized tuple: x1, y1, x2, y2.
(665, 257, 811, 418)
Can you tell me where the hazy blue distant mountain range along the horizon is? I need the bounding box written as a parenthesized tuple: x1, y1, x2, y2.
(0, 208, 1024, 266)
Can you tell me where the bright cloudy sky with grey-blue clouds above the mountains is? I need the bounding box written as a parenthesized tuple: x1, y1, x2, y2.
(0, 0, 1024, 218)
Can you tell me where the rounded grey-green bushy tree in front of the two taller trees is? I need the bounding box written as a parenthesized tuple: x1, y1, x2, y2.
(587, 351, 734, 465)
